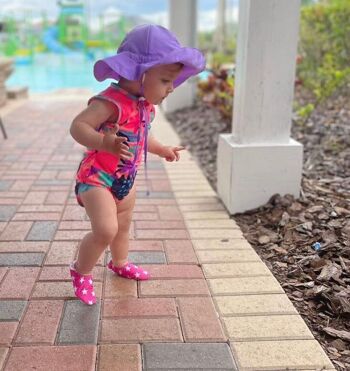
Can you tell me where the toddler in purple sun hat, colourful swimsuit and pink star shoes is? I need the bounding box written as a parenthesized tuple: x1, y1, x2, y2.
(70, 25, 205, 305)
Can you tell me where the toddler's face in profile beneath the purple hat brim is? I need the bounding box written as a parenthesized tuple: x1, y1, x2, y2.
(144, 63, 182, 104)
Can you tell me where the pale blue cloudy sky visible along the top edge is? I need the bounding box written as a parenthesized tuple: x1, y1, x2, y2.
(0, 0, 238, 30)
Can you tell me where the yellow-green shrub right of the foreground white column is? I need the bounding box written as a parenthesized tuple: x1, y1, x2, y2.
(297, 0, 350, 105)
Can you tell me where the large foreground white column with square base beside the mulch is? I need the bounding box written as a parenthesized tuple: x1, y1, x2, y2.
(217, 0, 303, 214)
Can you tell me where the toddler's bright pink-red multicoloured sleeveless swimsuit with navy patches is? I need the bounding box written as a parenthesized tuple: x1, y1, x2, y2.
(75, 83, 154, 206)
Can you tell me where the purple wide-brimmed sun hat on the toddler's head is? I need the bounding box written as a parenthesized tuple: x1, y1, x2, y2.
(94, 24, 205, 87)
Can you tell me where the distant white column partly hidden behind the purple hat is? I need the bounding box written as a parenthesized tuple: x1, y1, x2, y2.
(163, 0, 197, 112)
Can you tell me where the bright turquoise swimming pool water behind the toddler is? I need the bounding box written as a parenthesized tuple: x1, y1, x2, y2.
(6, 52, 110, 93)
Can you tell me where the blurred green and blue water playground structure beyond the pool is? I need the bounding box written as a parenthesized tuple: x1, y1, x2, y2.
(0, 0, 127, 64)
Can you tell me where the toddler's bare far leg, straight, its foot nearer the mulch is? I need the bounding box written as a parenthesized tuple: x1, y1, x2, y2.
(110, 186, 136, 266)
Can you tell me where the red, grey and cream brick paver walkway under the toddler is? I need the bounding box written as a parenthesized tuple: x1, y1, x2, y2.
(0, 97, 333, 371)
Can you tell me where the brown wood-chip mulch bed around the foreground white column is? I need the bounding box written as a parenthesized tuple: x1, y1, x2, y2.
(168, 86, 350, 371)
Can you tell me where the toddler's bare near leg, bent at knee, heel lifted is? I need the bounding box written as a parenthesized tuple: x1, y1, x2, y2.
(75, 187, 118, 274)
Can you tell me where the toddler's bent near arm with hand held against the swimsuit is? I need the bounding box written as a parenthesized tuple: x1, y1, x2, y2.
(70, 99, 132, 159)
